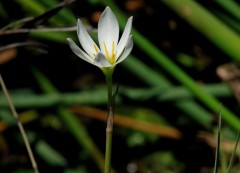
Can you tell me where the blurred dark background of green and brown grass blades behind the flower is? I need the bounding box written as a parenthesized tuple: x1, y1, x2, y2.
(0, 0, 240, 173)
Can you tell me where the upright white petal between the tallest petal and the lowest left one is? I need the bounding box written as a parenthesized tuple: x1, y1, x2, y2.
(77, 19, 99, 57)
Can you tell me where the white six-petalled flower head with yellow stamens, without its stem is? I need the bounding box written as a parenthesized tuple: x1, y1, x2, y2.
(67, 7, 133, 69)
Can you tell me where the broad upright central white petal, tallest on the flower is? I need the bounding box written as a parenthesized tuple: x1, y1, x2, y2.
(98, 7, 119, 55)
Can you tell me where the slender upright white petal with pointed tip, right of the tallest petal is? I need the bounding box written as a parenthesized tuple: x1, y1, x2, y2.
(116, 17, 133, 57)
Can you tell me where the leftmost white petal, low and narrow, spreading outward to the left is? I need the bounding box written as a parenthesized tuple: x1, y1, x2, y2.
(67, 38, 93, 64)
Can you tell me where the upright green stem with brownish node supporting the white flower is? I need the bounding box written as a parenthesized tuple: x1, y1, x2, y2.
(104, 70, 114, 173)
